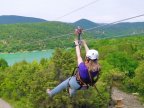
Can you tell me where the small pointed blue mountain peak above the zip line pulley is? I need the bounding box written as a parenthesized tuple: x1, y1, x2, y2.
(73, 19, 100, 29)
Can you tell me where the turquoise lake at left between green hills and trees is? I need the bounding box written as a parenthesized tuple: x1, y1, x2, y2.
(0, 49, 54, 66)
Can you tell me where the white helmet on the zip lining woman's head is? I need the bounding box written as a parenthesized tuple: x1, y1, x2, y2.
(86, 49, 99, 60)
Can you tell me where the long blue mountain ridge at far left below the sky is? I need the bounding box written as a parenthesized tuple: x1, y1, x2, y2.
(0, 15, 47, 24)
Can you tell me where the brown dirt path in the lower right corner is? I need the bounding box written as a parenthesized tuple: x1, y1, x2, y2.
(110, 87, 144, 108)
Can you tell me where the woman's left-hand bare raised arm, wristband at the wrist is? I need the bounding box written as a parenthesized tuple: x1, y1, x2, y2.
(74, 40, 83, 65)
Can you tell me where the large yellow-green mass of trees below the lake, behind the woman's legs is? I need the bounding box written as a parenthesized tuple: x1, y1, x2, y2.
(0, 49, 109, 108)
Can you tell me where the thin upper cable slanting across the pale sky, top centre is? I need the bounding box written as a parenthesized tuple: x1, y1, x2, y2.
(55, 0, 99, 20)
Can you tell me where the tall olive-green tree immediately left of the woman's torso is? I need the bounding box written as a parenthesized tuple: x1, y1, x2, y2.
(52, 49, 77, 80)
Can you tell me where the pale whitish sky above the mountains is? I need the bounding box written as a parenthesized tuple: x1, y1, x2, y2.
(0, 0, 144, 23)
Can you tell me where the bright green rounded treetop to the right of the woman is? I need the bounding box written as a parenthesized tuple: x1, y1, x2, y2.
(107, 52, 138, 78)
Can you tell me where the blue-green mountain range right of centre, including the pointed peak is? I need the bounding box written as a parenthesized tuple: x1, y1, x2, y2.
(73, 19, 144, 38)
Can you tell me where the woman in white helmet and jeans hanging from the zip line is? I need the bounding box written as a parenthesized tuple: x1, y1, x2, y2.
(47, 40, 100, 97)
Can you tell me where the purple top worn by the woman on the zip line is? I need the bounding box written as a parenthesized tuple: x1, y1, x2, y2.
(78, 62, 98, 83)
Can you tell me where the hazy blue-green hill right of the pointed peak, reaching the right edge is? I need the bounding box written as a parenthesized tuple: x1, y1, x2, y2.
(92, 22, 144, 38)
